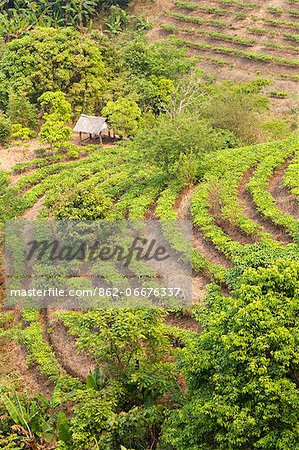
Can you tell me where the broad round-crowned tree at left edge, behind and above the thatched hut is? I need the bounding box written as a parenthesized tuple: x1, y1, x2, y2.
(0, 28, 107, 113)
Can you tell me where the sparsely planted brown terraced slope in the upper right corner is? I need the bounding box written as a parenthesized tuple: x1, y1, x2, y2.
(153, 0, 299, 107)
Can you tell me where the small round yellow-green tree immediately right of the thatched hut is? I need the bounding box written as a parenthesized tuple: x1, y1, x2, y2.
(102, 97, 142, 137)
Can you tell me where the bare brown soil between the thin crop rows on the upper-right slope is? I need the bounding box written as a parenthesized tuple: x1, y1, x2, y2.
(135, 0, 298, 113)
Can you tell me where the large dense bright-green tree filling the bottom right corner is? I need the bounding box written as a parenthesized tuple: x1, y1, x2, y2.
(163, 261, 299, 450)
